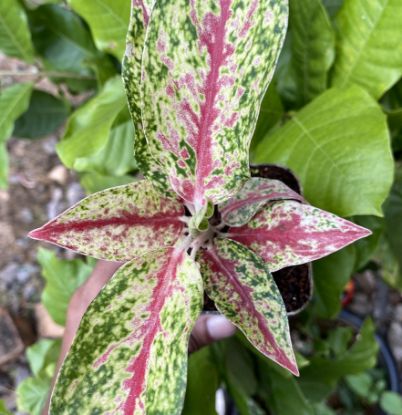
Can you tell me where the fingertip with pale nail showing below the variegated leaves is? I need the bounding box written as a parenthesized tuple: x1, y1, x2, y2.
(188, 314, 236, 353)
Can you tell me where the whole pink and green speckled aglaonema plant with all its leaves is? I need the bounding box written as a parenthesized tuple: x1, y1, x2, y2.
(30, 0, 369, 415)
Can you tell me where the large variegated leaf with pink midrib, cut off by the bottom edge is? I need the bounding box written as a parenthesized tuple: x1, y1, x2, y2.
(50, 248, 203, 415)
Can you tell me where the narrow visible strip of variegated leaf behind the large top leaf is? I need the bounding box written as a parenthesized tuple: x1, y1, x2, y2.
(123, 0, 169, 194)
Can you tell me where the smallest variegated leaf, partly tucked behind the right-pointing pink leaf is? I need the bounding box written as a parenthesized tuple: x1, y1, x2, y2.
(219, 177, 303, 226)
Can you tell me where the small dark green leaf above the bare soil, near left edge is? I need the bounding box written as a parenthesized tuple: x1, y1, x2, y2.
(13, 90, 69, 138)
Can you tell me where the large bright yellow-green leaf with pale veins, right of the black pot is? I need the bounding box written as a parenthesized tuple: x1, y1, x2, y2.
(253, 86, 394, 216)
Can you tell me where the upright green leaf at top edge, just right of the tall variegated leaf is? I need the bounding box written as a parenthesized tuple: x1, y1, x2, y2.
(289, 0, 335, 104)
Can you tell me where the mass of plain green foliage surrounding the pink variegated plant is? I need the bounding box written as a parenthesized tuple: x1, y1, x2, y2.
(0, 0, 402, 415)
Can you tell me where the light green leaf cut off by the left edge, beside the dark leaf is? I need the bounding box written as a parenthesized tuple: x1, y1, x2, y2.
(0, 84, 32, 188)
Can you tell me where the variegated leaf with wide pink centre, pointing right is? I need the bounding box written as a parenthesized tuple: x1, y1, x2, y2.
(227, 200, 371, 272)
